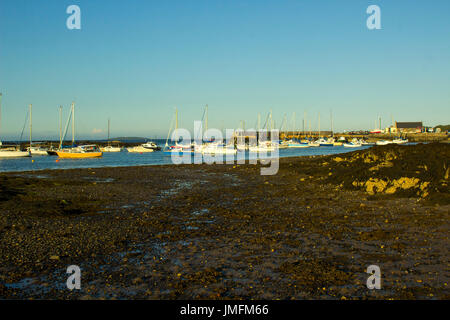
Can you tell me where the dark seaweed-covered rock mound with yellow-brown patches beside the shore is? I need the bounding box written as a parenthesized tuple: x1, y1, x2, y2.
(327, 143, 450, 204)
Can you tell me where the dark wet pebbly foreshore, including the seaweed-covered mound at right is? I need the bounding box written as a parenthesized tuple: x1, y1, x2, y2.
(0, 144, 450, 299)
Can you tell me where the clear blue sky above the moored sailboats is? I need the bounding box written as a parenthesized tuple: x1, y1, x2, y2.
(0, 0, 450, 139)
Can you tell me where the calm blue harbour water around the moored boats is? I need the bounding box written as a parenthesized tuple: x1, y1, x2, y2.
(0, 146, 370, 172)
